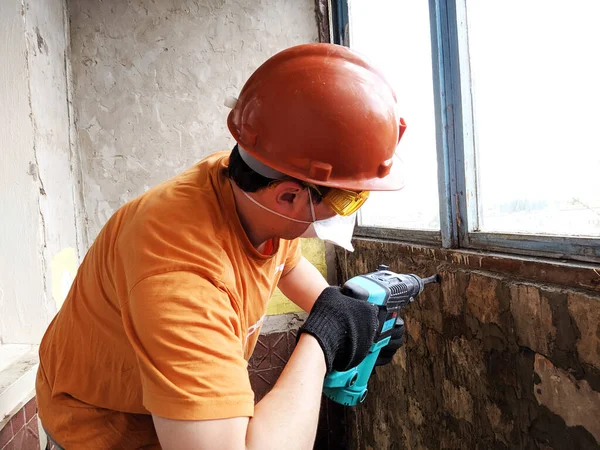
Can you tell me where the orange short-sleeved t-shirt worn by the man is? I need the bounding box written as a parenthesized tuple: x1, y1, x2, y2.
(36, 153, 301, 449)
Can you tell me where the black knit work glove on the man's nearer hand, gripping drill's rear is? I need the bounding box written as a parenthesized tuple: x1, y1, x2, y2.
(298, 287, 379, 373)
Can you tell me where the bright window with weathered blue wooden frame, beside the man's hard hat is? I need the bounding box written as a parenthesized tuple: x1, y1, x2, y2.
(332, 0, 600, 262)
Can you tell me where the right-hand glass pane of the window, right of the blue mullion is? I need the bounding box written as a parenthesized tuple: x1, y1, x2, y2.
(467, 0, 600, 236)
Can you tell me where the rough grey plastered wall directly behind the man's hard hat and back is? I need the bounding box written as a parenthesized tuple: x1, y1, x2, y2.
(69, 0, 318, 245)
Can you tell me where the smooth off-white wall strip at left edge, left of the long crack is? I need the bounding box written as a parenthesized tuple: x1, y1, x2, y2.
(0, 1, 45, 343)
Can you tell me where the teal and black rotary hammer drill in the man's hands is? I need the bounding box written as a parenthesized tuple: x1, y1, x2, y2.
(323, 265, 440, 406)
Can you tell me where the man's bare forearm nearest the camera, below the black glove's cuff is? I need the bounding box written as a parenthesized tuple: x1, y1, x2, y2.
(246, 334, 326, 450)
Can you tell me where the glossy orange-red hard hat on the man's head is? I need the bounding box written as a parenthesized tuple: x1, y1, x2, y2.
(227, 44, 406, 191)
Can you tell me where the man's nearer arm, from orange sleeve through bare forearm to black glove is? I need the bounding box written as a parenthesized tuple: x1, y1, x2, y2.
(141, 272, 377, 450)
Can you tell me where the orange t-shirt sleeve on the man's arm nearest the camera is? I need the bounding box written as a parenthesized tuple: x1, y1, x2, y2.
(123, 272, 254, 420)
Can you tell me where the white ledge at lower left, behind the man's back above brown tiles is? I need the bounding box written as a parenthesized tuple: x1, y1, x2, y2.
(0, 344, 39, 430)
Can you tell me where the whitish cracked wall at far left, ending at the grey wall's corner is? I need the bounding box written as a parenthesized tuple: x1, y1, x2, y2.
(0, 0, 78, 344)
